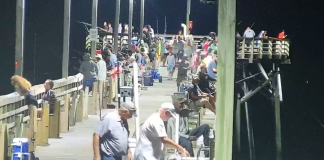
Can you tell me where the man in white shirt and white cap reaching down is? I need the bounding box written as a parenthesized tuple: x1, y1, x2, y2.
(134, 103, 190, 160)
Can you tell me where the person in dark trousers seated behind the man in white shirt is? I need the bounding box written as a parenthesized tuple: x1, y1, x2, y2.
(175, 102, 210, 157)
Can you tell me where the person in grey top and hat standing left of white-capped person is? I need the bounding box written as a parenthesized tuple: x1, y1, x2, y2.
(79, 53, 98, 92)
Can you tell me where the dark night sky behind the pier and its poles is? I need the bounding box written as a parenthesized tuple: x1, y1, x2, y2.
(0, 0, 324, 160)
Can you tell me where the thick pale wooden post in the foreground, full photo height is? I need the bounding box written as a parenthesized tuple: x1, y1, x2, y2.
(215, 0, 236, 160)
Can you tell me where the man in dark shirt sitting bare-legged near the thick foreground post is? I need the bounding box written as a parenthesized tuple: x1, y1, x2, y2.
(188, 75, 216, 114)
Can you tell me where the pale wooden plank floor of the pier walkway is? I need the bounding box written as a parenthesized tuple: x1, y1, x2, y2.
(35, 71, 176, 160)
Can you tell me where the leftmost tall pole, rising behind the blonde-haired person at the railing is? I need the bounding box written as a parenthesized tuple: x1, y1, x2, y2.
(15, 0, 25, 76)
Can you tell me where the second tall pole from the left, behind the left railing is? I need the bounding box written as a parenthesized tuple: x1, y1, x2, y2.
(62, 0, 71, 78)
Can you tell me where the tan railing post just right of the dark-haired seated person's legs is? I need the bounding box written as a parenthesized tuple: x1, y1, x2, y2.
(49, 100, 61, 138)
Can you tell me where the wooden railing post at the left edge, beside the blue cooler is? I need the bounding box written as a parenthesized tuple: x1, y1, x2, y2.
(0, 123, 8, 160)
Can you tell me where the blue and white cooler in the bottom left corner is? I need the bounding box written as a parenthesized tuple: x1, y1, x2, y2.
(11, 138, 30, 160)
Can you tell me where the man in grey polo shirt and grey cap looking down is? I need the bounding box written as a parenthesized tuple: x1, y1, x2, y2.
(93, 102, 137, 160)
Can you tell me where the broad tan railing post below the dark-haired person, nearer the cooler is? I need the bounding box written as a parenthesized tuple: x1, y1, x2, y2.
(36, 103, 49, 146)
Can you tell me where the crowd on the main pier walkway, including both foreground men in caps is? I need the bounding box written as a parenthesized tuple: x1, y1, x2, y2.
(11, 24, 217, 160)
